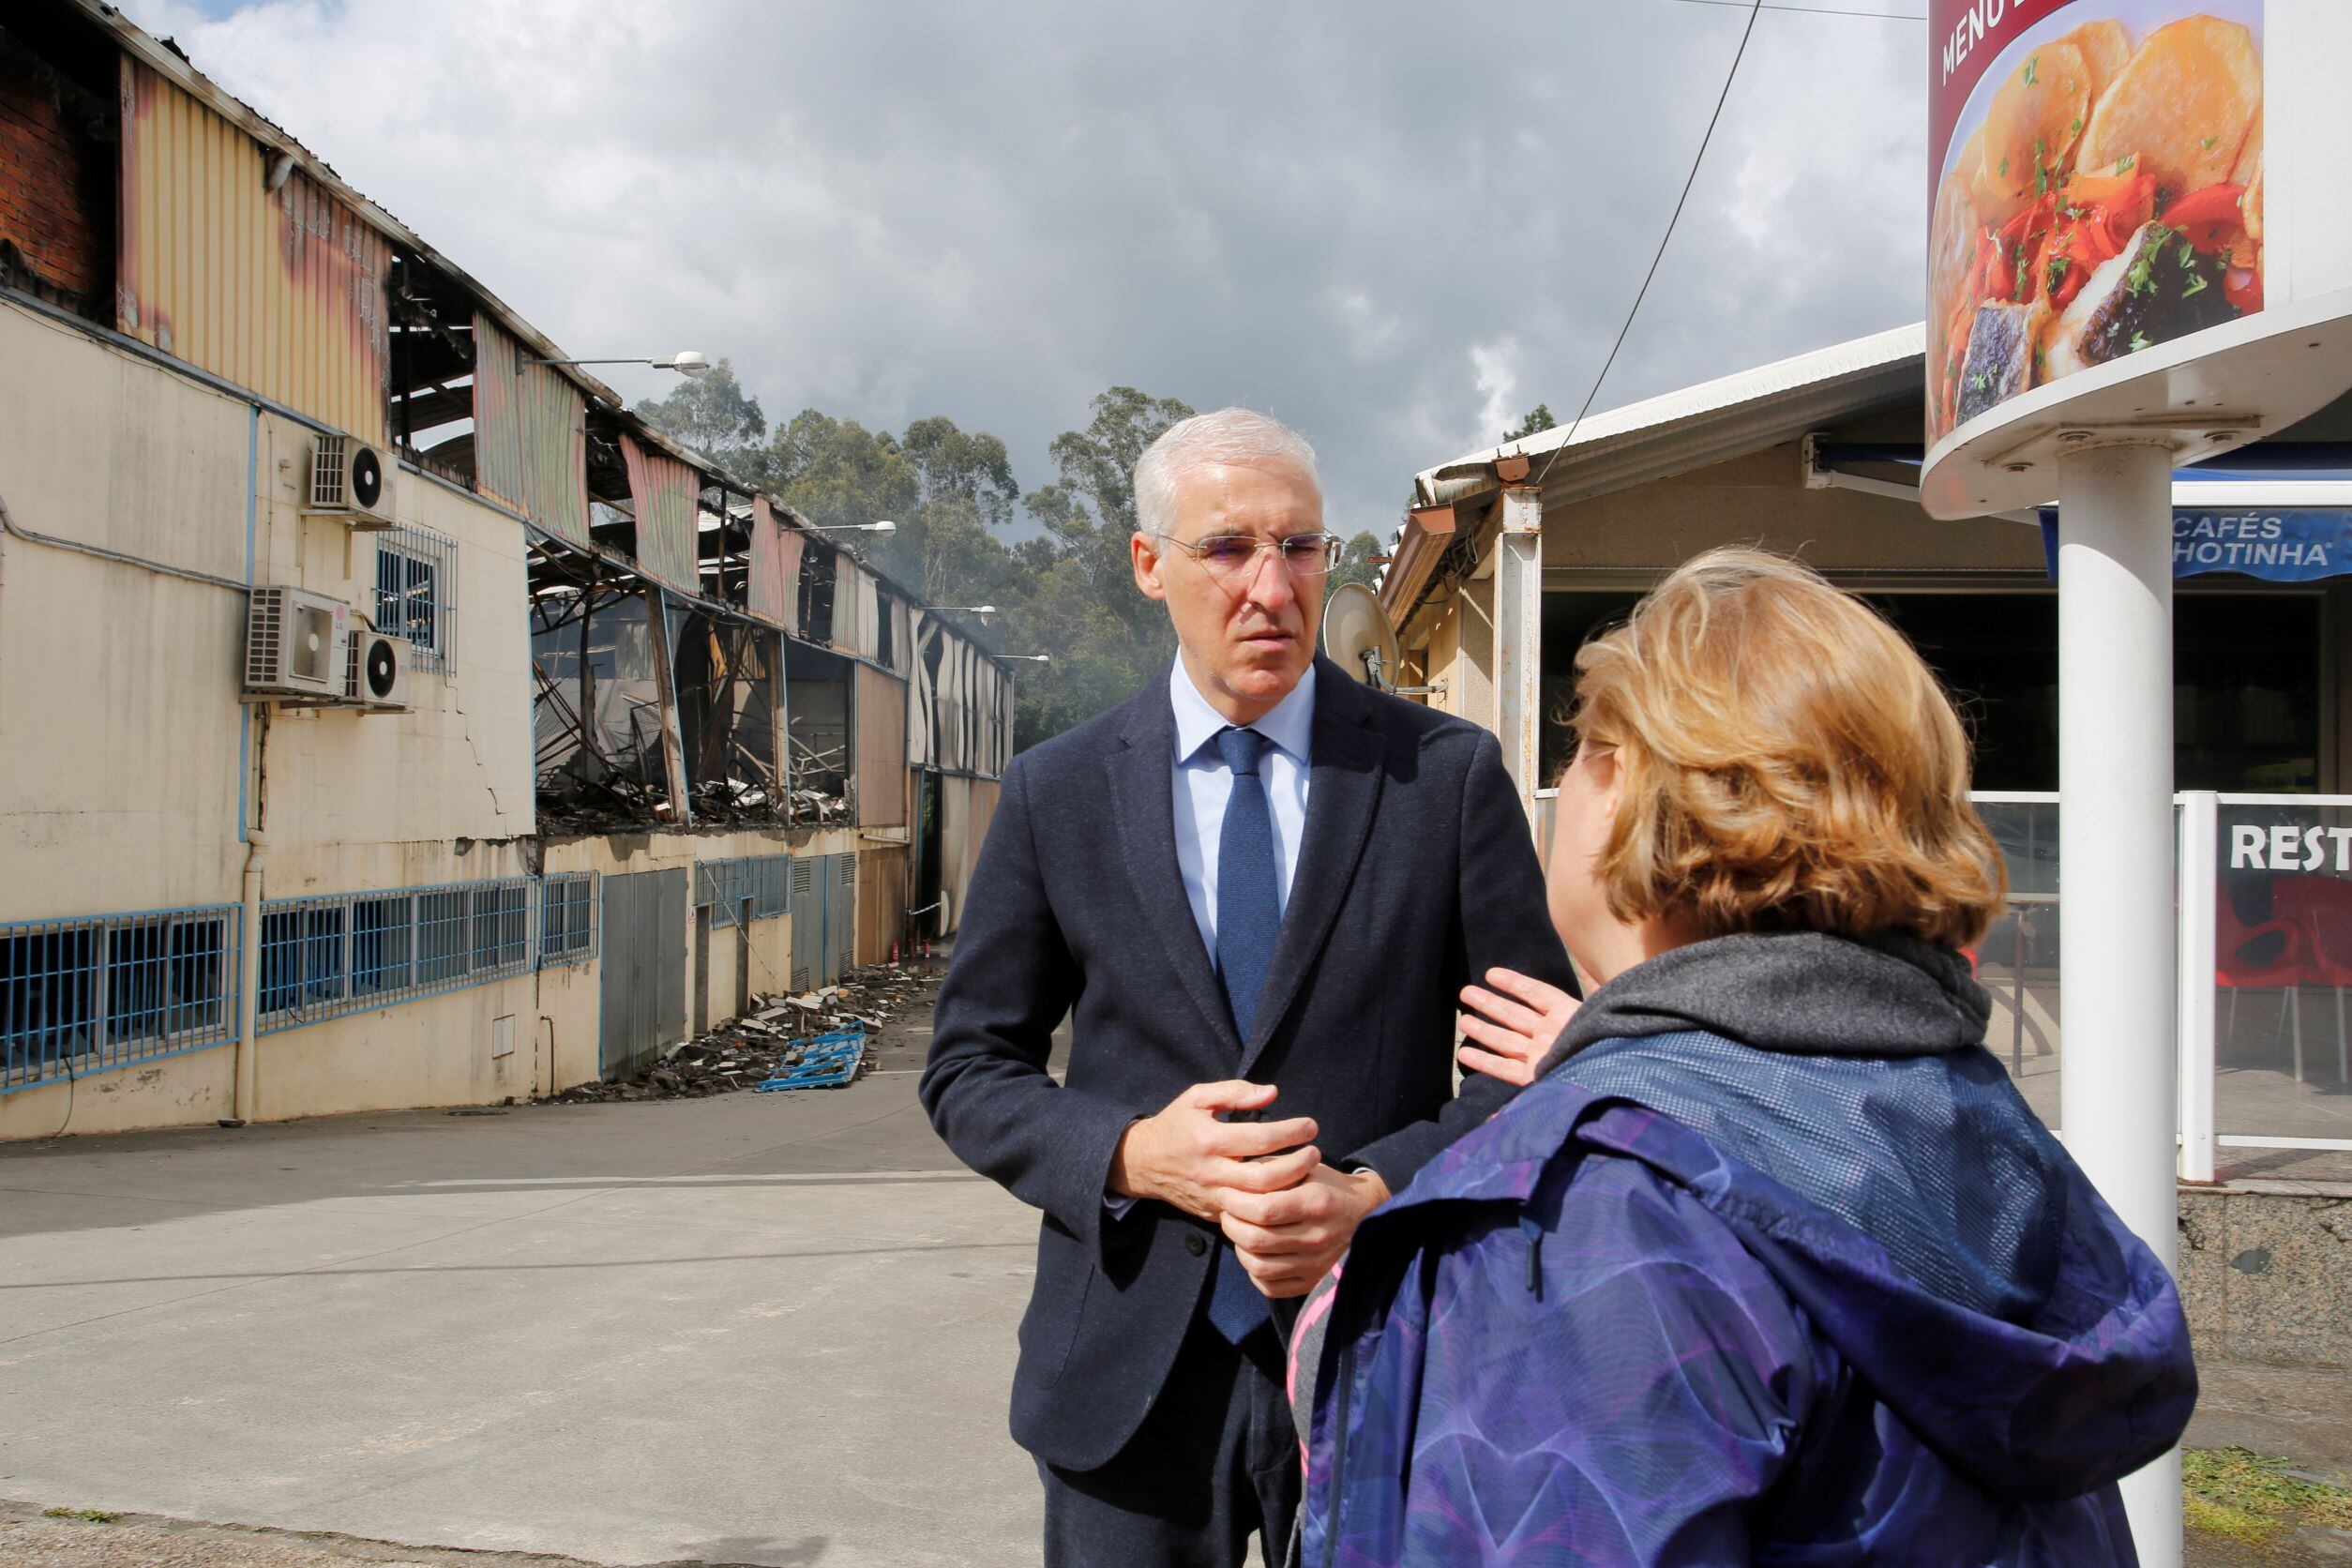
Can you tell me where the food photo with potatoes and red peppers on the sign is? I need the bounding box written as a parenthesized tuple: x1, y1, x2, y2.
(1929, 0, 2263, 442)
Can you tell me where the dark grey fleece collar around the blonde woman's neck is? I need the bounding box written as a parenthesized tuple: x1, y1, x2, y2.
(1543, 931, 1992, 1072)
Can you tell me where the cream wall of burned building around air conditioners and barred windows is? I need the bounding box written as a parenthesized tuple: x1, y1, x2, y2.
(0, 303, 538, 1138)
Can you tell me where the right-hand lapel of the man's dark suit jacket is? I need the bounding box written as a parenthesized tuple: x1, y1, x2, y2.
(1242, 658, 1385, 1077)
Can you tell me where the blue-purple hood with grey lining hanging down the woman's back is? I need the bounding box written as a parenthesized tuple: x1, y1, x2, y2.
(1366, 938, 2196, 1502)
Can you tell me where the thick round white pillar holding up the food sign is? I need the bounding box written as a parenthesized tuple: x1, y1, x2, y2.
(2058, 442, 2180, 1568)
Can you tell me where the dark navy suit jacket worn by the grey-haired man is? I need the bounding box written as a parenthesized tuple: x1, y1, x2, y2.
(922, 660, 1574, 1470)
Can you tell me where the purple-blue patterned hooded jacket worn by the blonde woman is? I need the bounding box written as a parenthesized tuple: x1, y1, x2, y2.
(1293, 1032, 2196, 1568)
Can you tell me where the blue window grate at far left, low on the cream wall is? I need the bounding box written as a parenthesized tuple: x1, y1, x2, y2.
(0, 905, 242, 1093)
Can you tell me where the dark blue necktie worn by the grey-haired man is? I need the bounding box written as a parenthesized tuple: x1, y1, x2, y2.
(1209, 729, 1282, 1345)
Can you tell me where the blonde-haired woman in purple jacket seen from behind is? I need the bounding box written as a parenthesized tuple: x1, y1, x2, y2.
(1293, 550, 2196, 1568)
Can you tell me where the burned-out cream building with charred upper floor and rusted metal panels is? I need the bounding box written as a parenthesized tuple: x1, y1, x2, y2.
(0, 0, 1011, 1138)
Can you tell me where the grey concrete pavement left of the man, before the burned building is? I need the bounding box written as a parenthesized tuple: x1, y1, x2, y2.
(0, 1039, 1037, 1568)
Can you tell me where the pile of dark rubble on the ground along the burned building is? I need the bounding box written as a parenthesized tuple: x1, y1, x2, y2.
(555, 964, 939, 1105)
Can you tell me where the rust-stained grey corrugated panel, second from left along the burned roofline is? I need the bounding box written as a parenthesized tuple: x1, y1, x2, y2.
(473, 310, 588, 546)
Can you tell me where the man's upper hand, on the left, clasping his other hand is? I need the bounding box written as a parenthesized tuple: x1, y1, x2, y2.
(1108, 1079, 1321, 1225)
